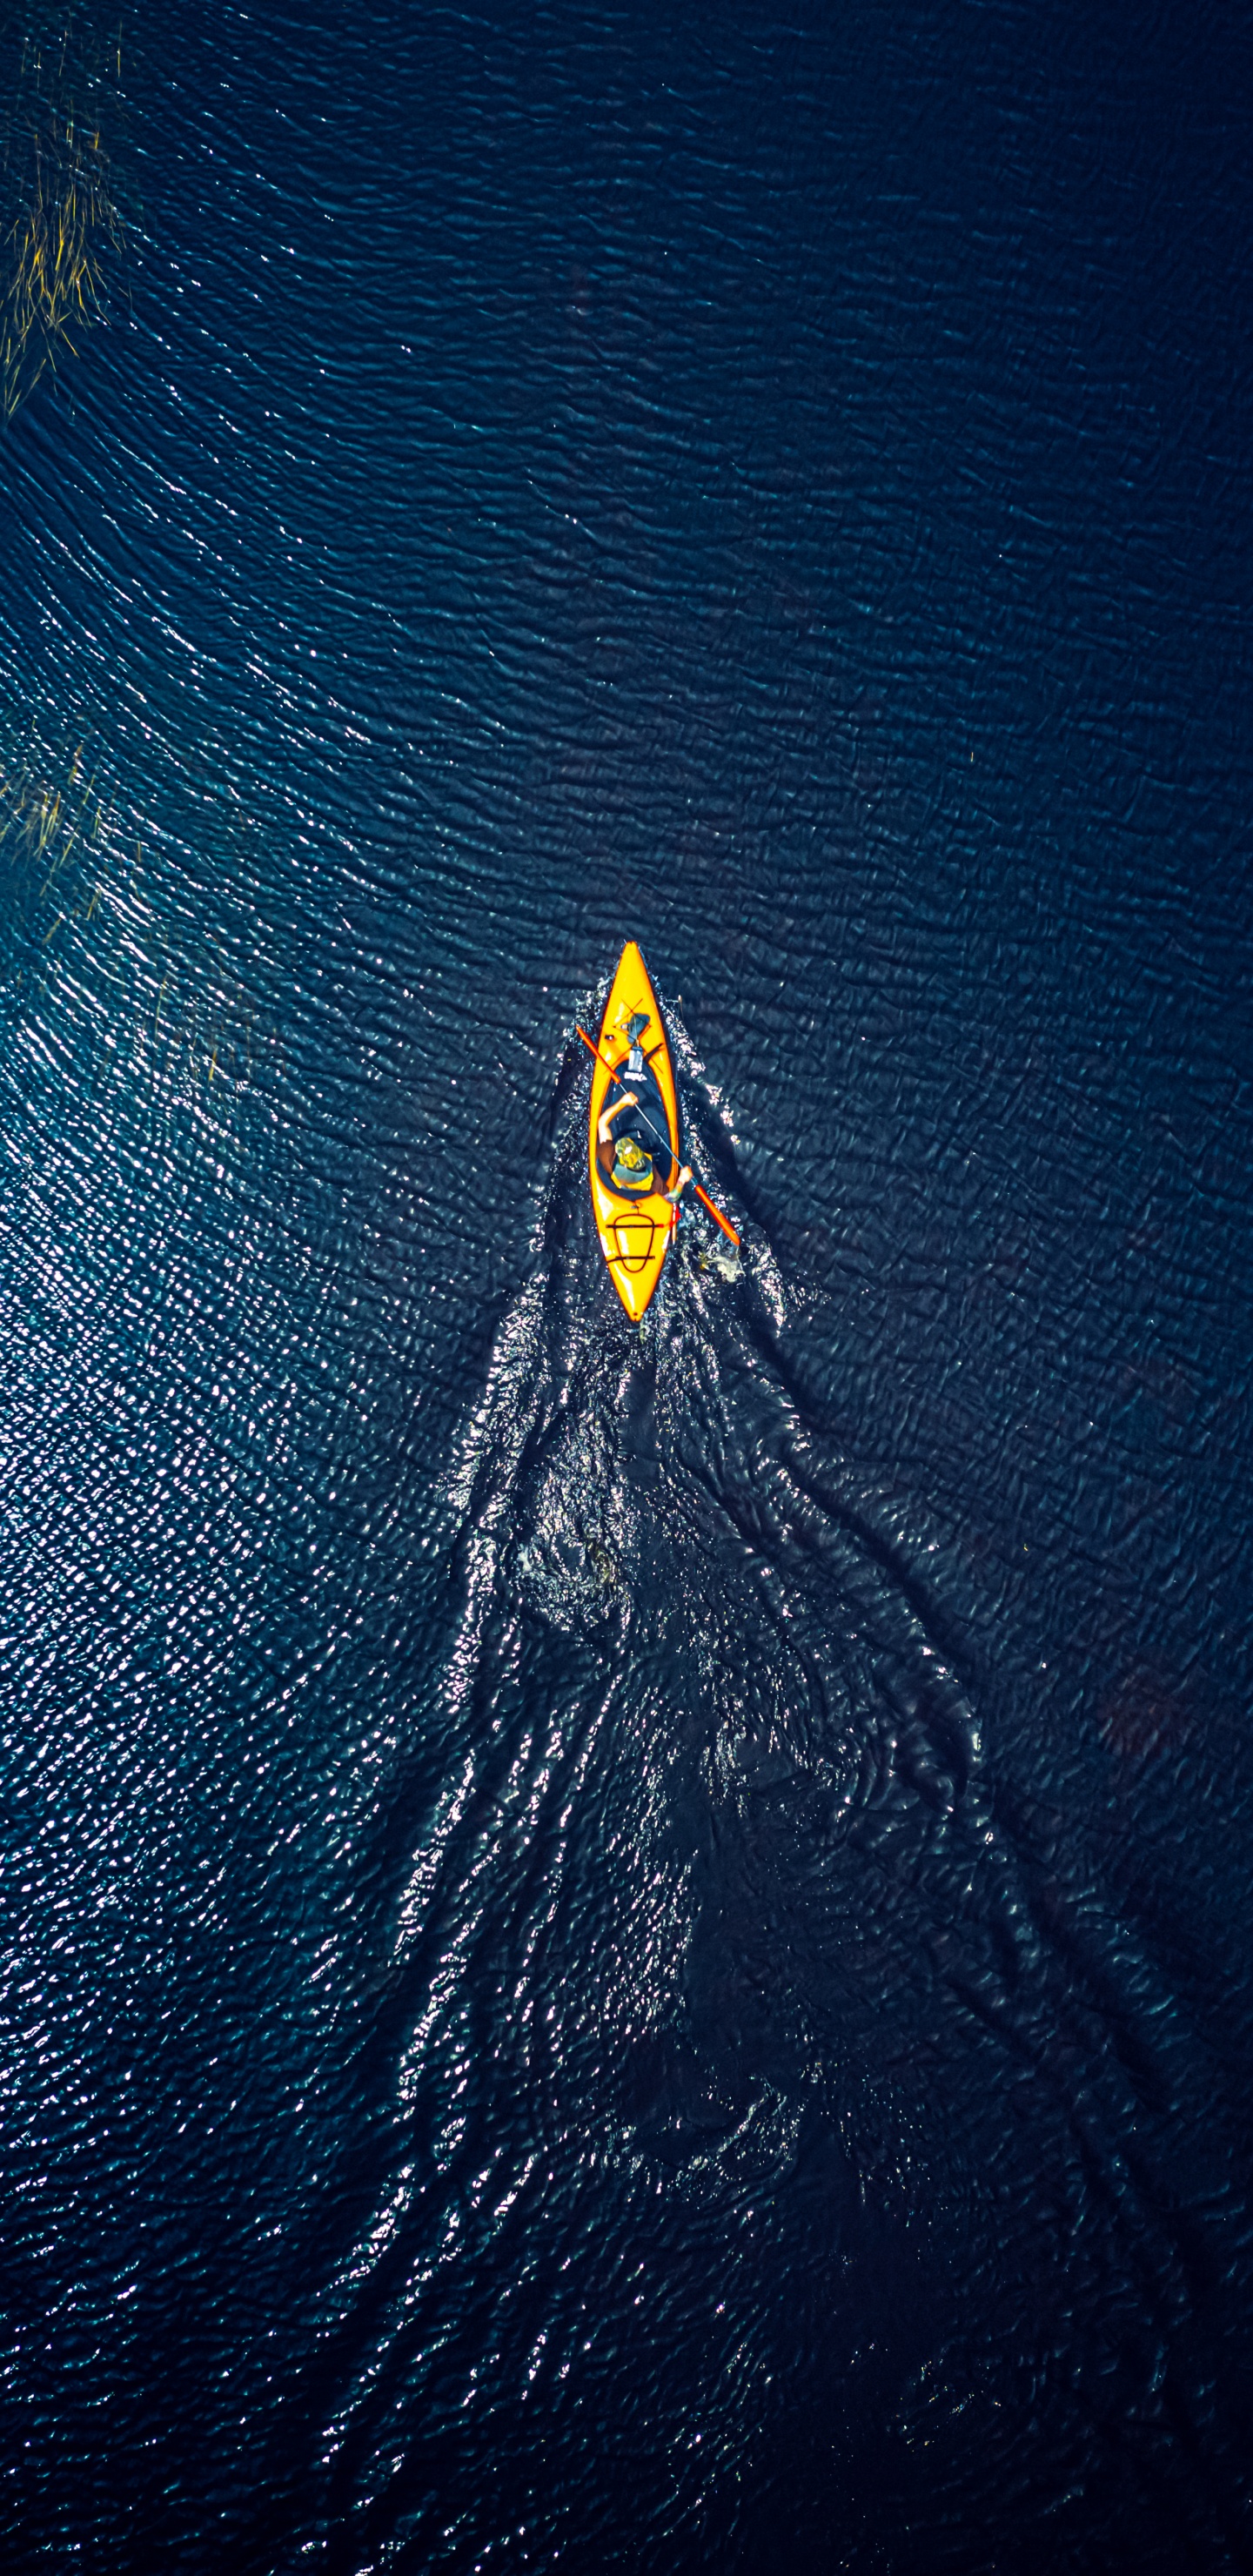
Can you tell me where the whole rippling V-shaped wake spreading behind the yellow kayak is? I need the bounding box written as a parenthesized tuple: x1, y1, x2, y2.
(291, 999, 1232, 2576)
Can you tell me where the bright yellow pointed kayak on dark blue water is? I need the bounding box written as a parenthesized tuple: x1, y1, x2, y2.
(588, 940, 678, 1324)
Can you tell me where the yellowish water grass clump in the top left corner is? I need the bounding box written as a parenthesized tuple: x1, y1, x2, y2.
(0, 10, 124, 419)
